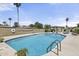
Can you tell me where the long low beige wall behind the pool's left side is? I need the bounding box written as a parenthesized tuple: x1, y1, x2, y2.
(0, 28, 44, 36)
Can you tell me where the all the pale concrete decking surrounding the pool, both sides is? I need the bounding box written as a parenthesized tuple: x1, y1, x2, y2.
(0, 33, 79, 56)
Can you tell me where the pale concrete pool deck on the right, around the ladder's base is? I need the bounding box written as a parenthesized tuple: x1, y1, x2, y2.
(45, 34, 79, 56)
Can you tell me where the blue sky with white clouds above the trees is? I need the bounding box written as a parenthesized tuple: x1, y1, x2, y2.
(0, 3, 79, 27)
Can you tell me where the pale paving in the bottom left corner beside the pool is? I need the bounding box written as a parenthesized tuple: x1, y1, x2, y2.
(0, 43, 16, 56)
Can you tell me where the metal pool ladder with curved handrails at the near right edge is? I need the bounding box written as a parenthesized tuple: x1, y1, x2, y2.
(47, 40, 61, 55)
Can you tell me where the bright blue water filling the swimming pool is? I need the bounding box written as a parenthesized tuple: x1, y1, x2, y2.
(6, 33, 64, 56)
